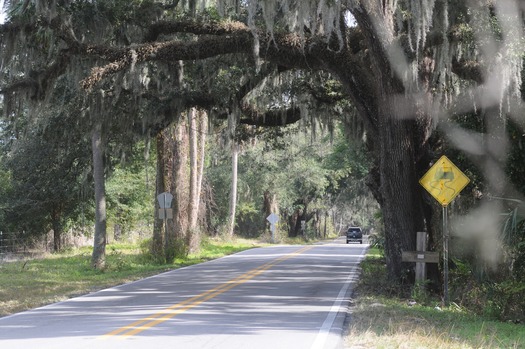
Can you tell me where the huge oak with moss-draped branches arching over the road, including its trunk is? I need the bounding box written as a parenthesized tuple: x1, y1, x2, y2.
(0, 0, 525, 279)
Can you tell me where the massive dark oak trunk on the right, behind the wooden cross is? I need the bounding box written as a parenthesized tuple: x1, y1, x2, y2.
(344, 2, 429, 282)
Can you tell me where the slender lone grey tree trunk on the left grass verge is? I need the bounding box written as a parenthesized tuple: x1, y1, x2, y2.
(91, 123, 106, 270)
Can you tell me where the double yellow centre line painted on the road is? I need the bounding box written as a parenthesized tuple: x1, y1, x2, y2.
(101, 246, 312, 338)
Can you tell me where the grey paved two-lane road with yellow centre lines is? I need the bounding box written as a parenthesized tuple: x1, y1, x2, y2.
(0, 239, 366, 349)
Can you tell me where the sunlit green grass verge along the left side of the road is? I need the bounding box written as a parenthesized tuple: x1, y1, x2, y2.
(0, 239, 258, 317)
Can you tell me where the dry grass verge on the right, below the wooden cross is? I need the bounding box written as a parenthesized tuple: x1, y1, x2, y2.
(345, 249, 525, 349)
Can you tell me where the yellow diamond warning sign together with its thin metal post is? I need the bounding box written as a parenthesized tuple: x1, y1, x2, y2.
(419, 155, 470, 306)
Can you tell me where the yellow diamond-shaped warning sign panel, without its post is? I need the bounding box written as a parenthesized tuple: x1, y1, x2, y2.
(419, 155, 470, 206)
